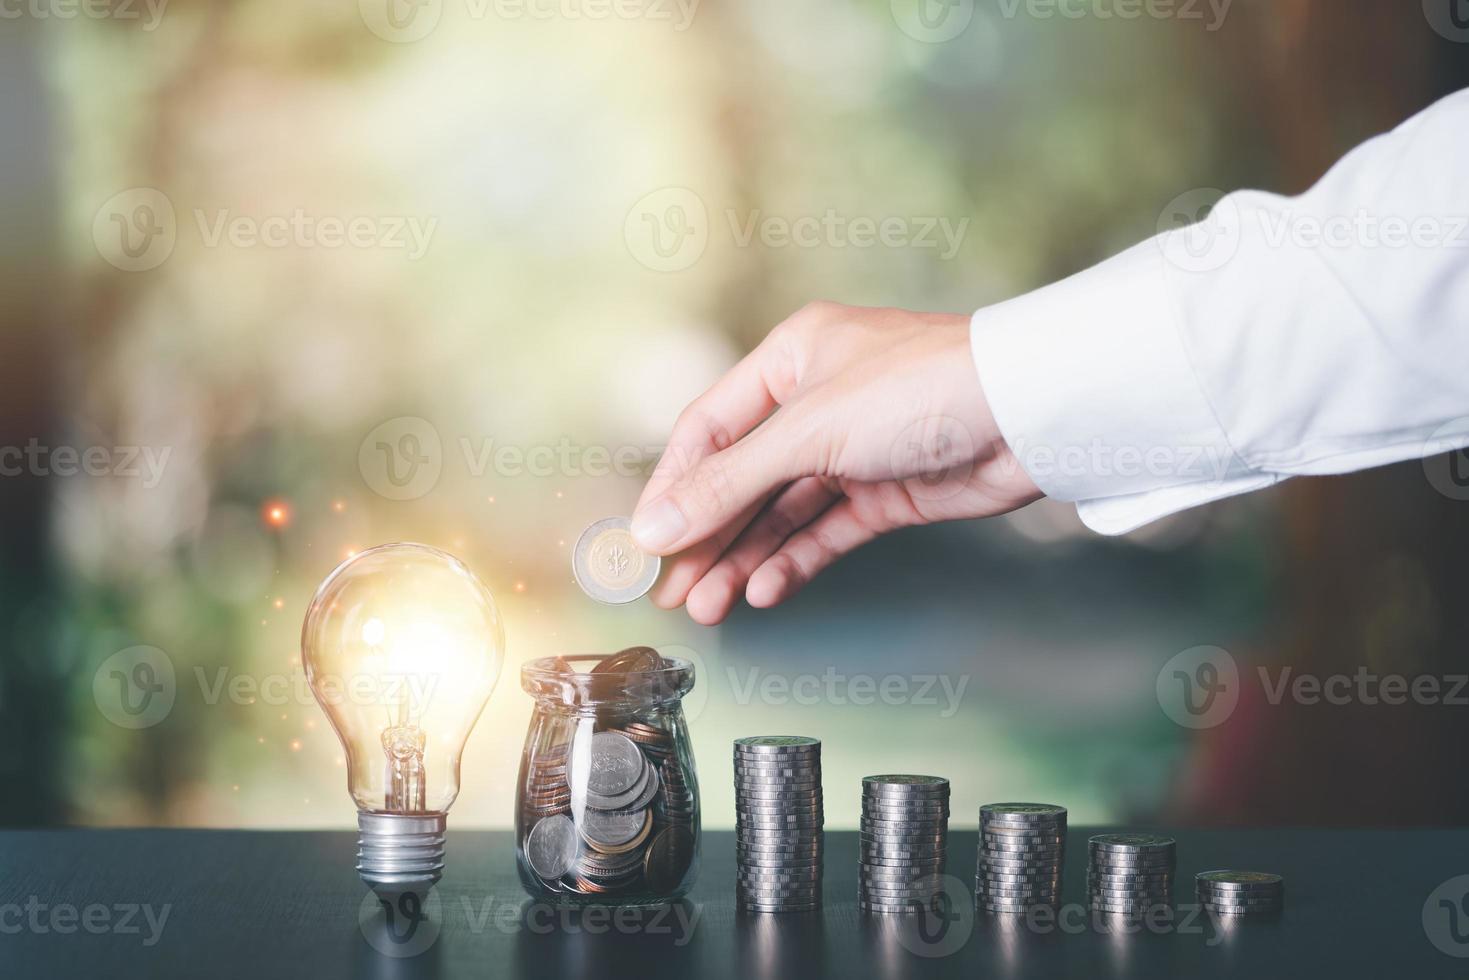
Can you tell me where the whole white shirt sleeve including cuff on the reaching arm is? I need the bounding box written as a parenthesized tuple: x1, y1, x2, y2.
(971, 91, 1469, 533)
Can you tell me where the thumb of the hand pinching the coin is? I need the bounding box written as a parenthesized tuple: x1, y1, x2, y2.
(632, 423, 805, 555)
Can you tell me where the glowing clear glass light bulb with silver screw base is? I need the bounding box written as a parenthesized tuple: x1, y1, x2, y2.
(301, 544, 505, 893)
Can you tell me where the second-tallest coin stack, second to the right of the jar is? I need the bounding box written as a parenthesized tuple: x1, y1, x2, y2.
(856, 776, 949, 912)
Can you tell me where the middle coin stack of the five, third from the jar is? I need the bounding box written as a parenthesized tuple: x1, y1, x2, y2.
(974, 804, 1066, 912)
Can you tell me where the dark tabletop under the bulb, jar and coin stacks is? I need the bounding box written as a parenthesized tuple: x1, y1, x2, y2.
(0, 829, 1469, 980)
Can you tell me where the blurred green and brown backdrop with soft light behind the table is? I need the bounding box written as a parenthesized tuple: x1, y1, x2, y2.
(0, 0, 1469, 827)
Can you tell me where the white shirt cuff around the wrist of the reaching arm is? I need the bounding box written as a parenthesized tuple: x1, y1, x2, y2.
(970, 241, 1278, 533)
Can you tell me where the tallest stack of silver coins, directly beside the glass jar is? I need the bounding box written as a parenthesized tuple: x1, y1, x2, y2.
(735, 735, 824, 912)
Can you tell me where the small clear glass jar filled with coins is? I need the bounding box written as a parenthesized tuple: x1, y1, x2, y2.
(516, 646, 699, 907)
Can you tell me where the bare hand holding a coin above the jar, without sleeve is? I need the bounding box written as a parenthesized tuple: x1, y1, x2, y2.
(632, 303, 1042, 626)
